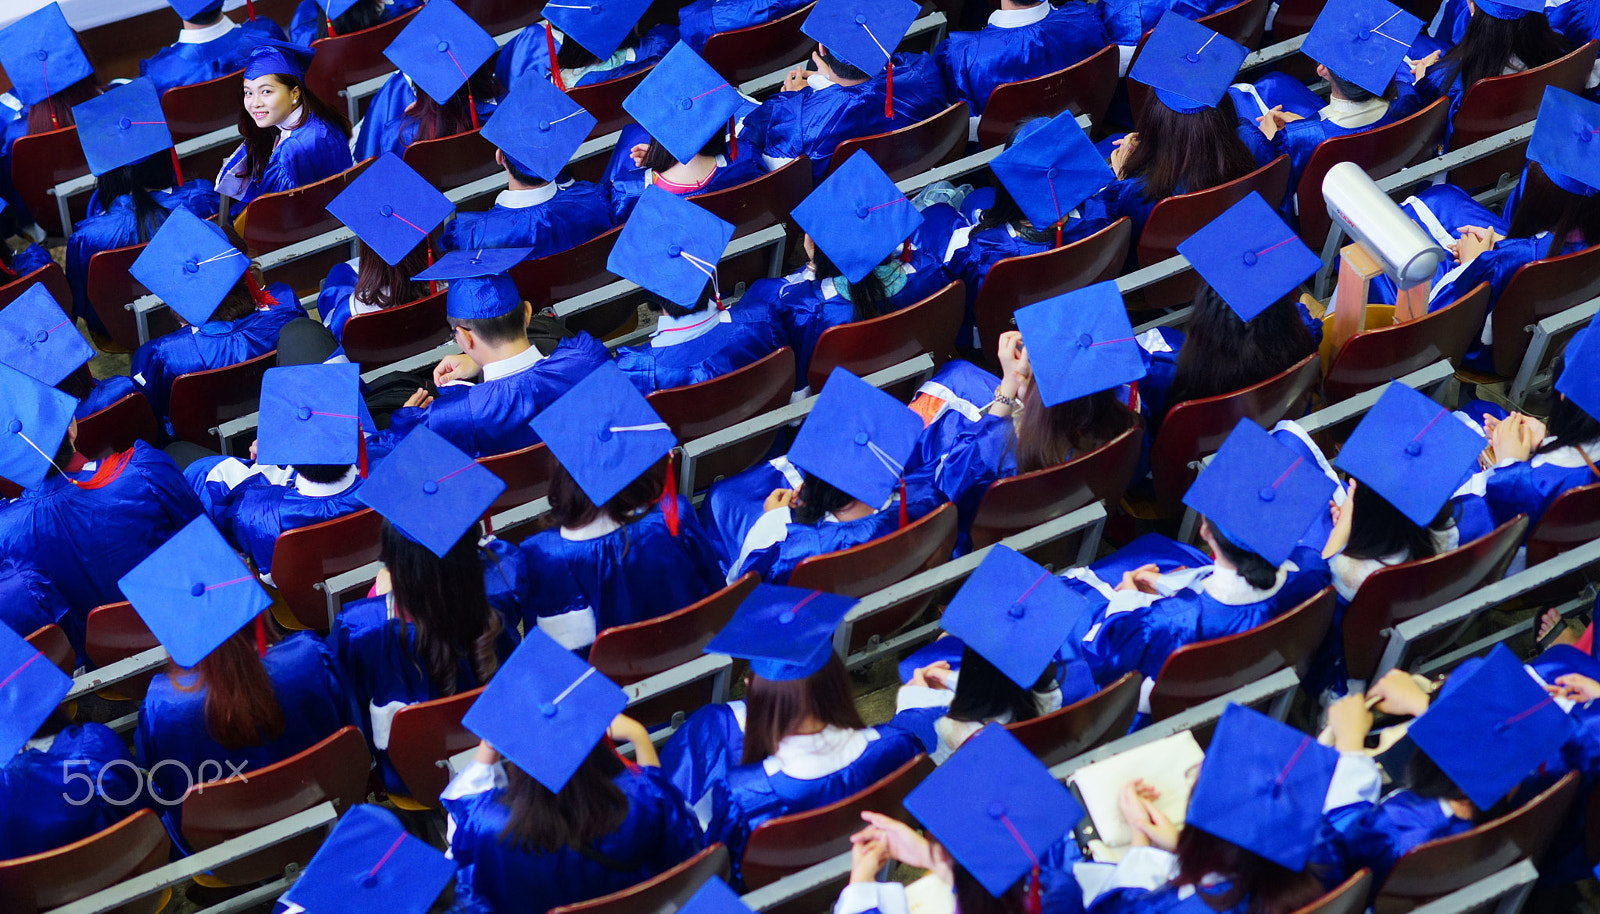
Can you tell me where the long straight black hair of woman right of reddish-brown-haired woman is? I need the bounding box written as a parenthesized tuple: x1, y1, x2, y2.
(378, 520, 501, 696)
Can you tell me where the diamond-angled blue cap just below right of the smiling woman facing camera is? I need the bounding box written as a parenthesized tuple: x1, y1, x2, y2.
(328, 152, 456, 266)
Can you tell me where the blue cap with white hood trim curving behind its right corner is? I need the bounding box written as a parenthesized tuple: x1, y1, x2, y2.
(1184, 418, 1334, 565)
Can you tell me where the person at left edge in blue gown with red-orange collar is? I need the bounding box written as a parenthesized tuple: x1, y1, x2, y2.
(0, 368, 200, 663)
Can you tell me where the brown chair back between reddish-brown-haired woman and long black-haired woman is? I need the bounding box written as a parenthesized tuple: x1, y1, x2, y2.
(272, 507, 384, 631)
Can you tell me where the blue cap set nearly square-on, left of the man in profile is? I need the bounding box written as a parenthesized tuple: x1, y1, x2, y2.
(256, 362, 362, 466)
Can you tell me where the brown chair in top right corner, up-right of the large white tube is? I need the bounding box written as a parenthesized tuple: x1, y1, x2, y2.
(1450, 42, 1600, 189)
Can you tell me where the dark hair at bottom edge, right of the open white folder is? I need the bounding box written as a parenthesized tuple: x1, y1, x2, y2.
(1173, 824, 1323, 914)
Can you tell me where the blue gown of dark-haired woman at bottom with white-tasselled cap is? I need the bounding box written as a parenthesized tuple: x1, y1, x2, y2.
(443, 767, 702, 914)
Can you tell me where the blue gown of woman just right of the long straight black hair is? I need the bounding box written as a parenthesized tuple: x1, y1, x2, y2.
(522, 496, 723, 650)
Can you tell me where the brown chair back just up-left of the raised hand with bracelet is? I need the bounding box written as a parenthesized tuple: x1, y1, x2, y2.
(806, 280, 966, 391)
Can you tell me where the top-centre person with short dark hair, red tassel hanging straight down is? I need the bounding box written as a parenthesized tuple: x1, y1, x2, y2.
(739, 0, 946, 181)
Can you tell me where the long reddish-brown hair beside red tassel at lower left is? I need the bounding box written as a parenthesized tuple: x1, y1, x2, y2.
(168, 615, 283, 749)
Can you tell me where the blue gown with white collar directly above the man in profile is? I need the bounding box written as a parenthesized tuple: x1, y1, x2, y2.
(438, 181, 613, 258)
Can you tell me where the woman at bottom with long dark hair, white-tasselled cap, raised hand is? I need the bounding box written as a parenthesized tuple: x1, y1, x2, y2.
(440, 631, 704, 914)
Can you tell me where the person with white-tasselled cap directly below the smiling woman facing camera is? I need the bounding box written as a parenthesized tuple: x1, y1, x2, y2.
(131, 210, 306, 432)
